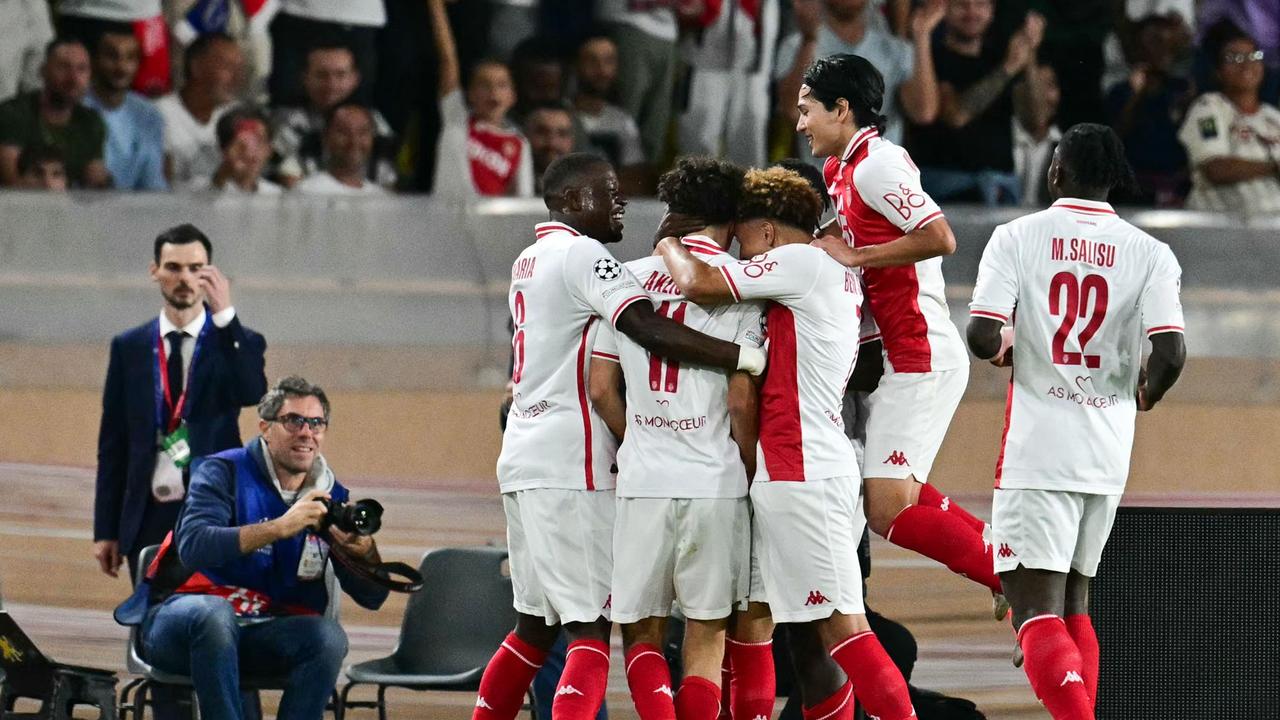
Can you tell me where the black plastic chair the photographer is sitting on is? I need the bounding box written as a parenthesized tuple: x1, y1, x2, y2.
(119, 544, 342, 720)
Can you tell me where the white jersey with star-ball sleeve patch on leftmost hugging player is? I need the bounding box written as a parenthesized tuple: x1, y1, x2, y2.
(498, 223, 649, 492)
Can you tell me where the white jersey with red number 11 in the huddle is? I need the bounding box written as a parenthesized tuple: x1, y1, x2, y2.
(593, 236, 764, 497)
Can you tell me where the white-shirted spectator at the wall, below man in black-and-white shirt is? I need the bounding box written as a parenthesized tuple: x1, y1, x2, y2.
(297, 102, 387, 195)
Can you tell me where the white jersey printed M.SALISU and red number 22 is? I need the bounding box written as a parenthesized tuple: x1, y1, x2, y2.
(970, 199, 1183, 495)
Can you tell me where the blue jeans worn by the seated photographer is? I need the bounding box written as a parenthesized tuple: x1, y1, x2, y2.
(142, 594, 347, 720)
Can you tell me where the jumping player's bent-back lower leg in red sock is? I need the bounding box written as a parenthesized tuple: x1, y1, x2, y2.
(863, 475, 1001, 593)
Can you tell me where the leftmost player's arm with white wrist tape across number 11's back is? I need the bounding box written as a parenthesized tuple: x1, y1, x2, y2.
(614, 302, 764, 375)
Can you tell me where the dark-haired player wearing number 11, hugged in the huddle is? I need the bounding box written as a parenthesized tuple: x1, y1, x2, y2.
(591, 158, 757, 720)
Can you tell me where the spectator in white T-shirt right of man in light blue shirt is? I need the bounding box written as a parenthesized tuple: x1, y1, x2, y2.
(156, 33, 244, 188)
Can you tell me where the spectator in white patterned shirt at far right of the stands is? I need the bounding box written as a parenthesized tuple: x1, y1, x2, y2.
(1178, 27, 1280, 214)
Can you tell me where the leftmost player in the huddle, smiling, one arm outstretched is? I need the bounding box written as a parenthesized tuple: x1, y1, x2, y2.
(472, 152, 764, 720)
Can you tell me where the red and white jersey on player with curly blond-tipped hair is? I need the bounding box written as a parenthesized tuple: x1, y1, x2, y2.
(721, 243, 863, 483)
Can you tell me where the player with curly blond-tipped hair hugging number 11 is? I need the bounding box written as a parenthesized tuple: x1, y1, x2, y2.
(658, 168, 915, 720)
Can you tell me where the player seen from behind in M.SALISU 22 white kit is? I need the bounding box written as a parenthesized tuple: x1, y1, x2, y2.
(968, 124, 1185, 720)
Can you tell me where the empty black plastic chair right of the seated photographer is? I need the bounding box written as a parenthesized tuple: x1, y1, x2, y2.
(338, 547, 532, 720)
